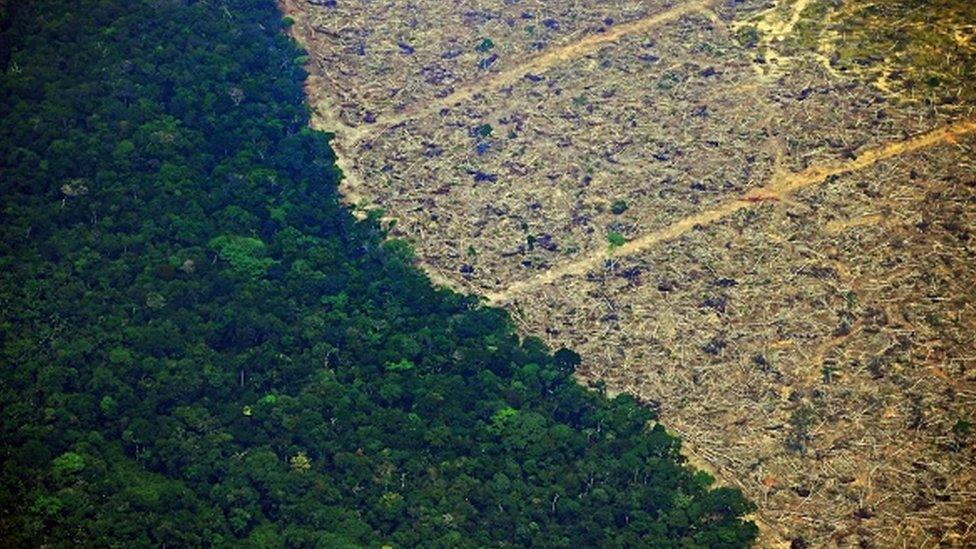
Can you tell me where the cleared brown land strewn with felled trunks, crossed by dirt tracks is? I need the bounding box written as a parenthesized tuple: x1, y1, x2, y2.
(284, 0, 976, 546)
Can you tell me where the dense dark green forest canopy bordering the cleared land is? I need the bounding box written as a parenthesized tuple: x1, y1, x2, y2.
(0, 0, 756, 547)
